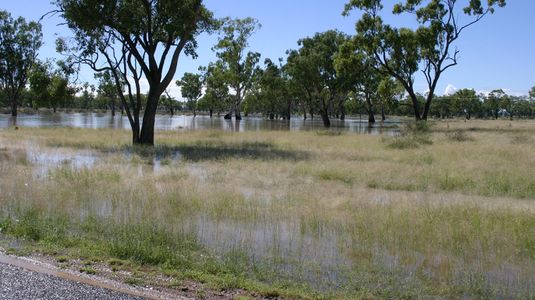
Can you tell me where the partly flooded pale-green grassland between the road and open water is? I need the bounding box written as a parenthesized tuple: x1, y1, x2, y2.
(0, 121, 535, 298)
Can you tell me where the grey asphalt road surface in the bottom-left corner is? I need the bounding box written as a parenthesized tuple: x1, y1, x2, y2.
(0, 263, 143, 300)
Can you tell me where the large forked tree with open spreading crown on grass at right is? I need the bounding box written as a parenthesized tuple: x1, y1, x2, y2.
(344, 0, 506, 120)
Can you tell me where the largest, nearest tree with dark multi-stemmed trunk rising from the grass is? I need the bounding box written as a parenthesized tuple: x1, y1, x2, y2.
(54, 0, 215, 145)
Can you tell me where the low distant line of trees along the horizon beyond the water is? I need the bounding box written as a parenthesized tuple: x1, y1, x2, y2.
(0, 85, 535, 119)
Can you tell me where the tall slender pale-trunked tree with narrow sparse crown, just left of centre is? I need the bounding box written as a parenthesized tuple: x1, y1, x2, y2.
(213, 18, 261, 120)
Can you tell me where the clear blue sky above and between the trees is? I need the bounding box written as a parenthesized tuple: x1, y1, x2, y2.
(0, 0, 535, 97)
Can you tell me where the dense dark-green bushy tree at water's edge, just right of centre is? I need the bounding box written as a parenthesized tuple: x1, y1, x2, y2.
(286, 30, 351, 127)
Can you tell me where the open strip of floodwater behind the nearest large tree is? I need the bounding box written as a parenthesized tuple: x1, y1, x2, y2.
(0, 112, 401, 135)
